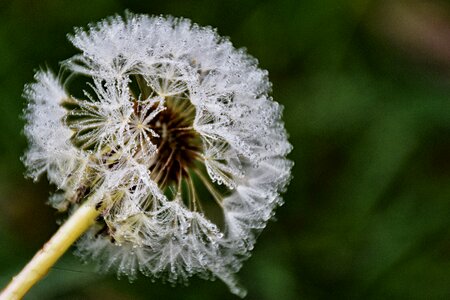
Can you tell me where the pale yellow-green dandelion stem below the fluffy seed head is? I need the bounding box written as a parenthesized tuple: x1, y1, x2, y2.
(0, 200, 101, 300)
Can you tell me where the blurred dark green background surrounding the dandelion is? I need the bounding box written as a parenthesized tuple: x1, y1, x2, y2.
(0, 0, 450, 300)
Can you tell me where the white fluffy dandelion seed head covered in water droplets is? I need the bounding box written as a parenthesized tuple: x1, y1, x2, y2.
(24, 14, 292, 296)
